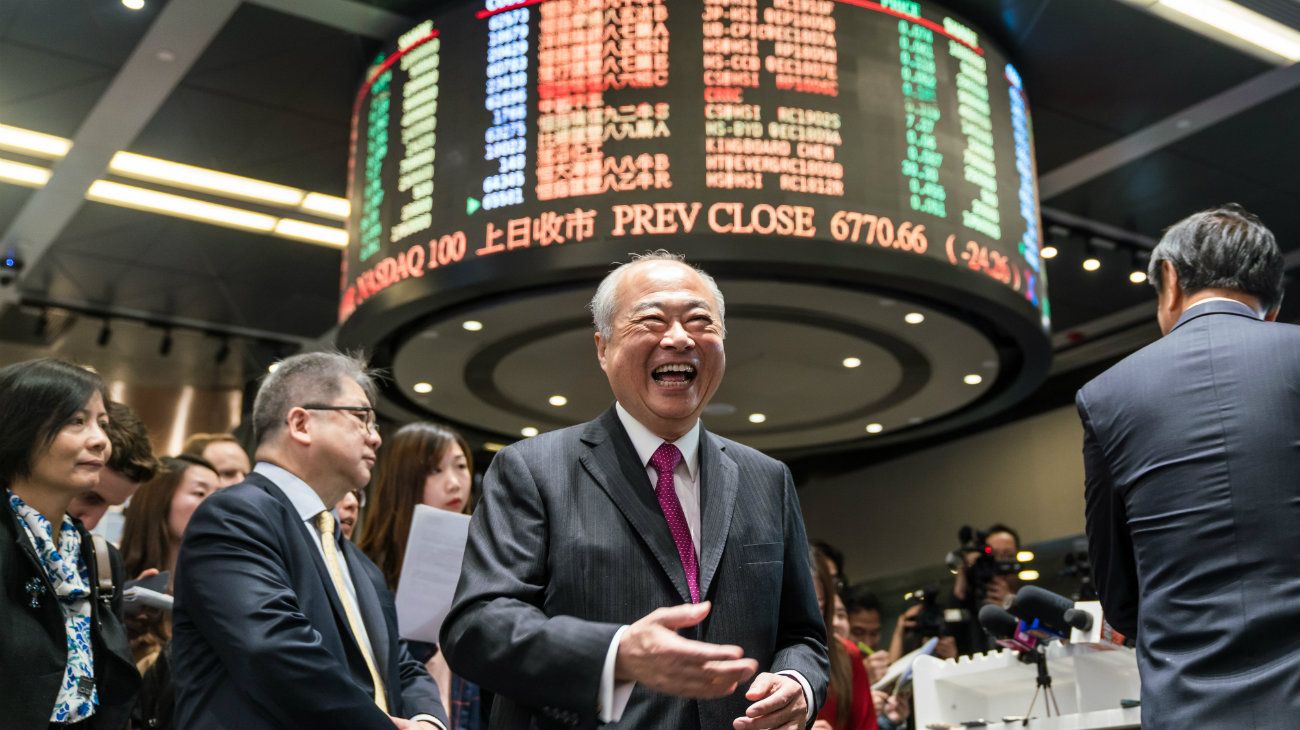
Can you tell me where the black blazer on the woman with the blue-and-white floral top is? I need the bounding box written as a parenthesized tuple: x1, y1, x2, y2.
(0, 491, 140, 730)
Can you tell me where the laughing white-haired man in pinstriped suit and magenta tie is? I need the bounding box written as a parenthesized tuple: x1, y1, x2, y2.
(442, 252, 827, 730)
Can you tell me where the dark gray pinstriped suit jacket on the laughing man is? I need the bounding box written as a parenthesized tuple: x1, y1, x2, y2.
(442, 408, 827, 730)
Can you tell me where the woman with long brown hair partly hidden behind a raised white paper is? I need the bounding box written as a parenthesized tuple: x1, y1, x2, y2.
(356, 422, 482, 730)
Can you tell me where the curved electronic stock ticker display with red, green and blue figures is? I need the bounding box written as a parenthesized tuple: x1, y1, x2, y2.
(341, 0, 1048, 327)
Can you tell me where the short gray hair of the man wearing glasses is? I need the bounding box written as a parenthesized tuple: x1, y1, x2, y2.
(252, 352, 377, 446)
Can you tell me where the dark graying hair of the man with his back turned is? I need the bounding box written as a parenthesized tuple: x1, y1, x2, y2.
(1147, 203, 1286, 312)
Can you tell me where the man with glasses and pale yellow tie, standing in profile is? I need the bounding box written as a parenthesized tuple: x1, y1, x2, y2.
(172, 352, 446, 730)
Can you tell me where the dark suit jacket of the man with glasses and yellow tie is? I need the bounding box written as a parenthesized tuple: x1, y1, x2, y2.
(172, 473, 447, 730)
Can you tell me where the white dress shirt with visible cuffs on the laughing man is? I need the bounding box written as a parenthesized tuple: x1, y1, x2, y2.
(597, 403, 813, 722)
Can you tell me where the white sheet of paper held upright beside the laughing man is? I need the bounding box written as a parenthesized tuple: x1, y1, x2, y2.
(398, 504, 469, 643)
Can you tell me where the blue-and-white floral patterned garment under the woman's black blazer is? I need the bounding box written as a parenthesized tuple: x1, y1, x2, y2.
(5, 490, 99, 724)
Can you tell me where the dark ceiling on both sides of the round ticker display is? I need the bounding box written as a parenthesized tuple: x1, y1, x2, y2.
(0, 0, 1300, 465)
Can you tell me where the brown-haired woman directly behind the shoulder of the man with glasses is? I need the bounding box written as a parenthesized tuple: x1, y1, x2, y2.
(122, 453, 221, 674)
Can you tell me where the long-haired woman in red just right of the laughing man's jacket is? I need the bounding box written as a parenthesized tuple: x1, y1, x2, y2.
(810, 548, 878, 730)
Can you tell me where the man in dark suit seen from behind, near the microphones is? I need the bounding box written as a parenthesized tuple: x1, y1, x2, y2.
(1076, 205, 1300, 730)
